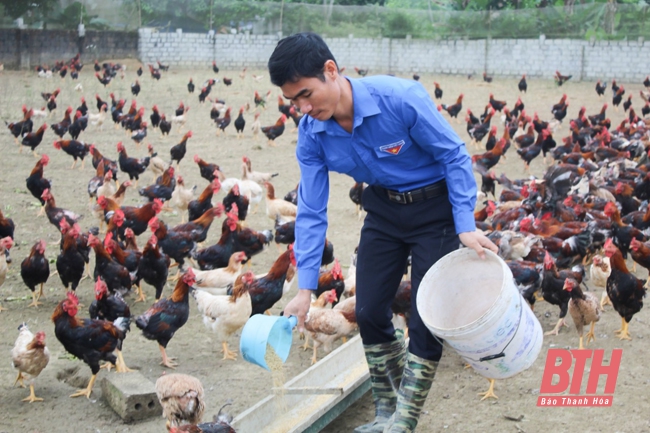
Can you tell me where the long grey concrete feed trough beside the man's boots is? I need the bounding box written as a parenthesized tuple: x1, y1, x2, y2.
(232, 335, 370, 433)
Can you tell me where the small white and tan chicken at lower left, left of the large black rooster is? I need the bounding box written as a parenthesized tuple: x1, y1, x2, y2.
(11, 323, 50, 403)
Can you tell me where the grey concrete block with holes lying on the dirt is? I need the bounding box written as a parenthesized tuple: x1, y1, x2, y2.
(102, 372, 162, 422)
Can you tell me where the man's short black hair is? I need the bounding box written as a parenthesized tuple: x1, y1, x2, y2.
(268, 32, 338, 87)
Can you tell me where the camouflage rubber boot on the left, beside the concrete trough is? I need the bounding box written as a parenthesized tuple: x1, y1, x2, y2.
(354, 332, 406, 433)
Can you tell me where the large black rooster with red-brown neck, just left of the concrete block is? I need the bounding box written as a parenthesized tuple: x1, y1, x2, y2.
(52, 292, 129, 398)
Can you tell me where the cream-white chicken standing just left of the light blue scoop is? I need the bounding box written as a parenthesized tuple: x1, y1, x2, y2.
(192, 271, 255, 361)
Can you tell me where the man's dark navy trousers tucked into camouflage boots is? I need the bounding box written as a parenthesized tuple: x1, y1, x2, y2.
(356, 186, 459, 361)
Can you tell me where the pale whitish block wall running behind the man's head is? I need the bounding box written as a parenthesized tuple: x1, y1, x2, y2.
(139, 29, 650, 80)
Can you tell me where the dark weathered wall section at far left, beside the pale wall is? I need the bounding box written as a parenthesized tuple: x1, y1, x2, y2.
(0, 29, 138, 69)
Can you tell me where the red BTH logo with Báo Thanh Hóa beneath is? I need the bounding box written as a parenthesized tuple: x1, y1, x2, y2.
(537, 349, 623, 407)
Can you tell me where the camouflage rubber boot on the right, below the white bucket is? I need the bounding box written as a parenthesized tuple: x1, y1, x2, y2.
(383, 353, 438, 433)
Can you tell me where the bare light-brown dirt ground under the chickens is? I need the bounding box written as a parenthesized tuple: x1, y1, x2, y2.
(0, 59, 650, 433)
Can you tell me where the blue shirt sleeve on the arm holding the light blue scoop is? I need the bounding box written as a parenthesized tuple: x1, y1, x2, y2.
(293, 119, 329, 290)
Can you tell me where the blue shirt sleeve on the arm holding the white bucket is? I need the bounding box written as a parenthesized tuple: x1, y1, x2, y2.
(402, 83, 476, 234)
